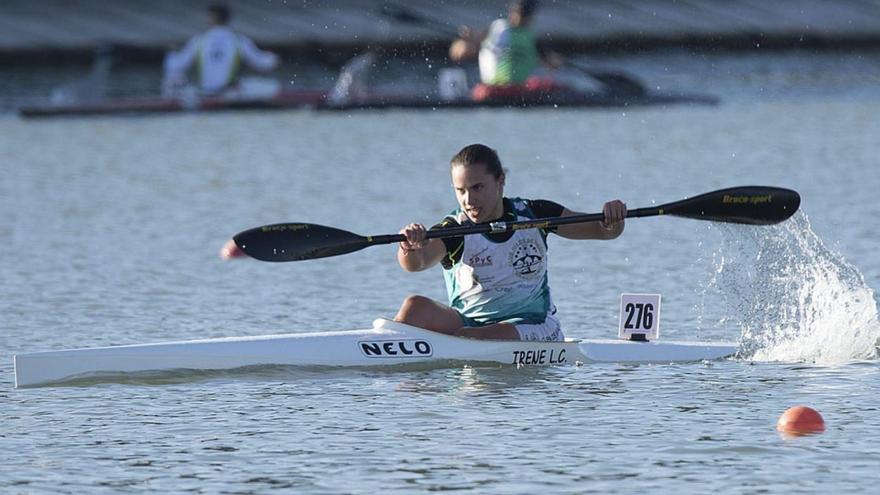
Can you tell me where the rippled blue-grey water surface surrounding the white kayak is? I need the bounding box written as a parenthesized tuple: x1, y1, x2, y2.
(0, 55, 880, 493)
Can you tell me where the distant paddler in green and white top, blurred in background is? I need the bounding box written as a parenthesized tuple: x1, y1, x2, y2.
(449, 0, 563, 86)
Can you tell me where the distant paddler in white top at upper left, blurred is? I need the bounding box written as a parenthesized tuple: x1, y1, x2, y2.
(163, 4, 278, 94)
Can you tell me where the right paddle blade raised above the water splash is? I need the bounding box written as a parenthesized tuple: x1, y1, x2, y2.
(659, 186, 801, 225)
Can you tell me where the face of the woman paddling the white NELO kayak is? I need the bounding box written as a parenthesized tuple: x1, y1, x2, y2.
(452, 163, 504, 223)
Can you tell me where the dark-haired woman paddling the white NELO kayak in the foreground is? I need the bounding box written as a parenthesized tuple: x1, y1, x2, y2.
(395, 144, 626, 340)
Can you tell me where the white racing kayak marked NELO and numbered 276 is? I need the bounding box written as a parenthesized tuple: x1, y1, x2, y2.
(14, 319, 737, 387)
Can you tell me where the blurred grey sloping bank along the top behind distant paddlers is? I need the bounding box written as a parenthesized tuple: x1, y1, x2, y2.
(0, 0, 880, 65)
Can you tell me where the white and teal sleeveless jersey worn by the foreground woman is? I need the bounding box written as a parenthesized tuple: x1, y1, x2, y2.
(439, 198, 562, 326)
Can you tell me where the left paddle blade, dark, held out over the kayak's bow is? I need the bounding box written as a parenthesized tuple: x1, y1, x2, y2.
(232, 223, 370, 261)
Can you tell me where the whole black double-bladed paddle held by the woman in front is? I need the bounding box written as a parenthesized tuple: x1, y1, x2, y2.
(233, 186, 801, 261)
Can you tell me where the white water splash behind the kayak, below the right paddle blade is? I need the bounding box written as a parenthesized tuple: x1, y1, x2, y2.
(707, 213, 880, 364)
